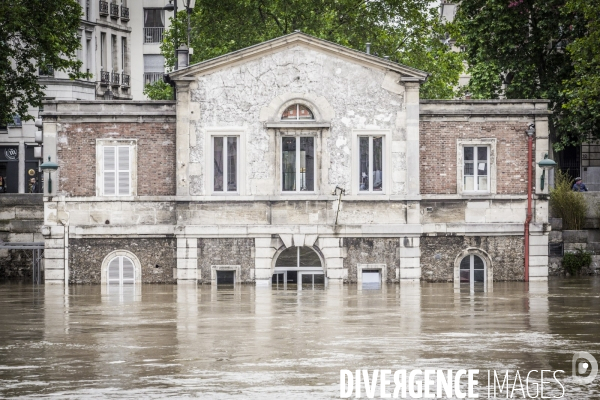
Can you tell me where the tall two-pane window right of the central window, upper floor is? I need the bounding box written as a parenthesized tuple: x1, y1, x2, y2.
(358, 136, 384, 192)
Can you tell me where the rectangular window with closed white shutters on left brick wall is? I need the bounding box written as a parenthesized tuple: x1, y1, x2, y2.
(96, 140, 137, 196)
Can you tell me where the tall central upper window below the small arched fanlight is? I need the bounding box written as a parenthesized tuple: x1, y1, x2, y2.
(281, 136, 315, 192)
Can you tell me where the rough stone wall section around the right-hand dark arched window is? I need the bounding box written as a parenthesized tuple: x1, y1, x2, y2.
(421, 236, 525, 282)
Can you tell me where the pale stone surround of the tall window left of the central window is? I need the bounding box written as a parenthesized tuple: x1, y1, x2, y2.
(205, 126, 246, 196)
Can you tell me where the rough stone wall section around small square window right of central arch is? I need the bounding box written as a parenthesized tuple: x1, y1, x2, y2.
(344, 238, 400, 283)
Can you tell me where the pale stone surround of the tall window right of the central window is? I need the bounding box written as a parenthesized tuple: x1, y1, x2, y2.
(352, 129, 392, 196)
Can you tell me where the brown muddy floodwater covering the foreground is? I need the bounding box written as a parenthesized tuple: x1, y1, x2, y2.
(0, 278, 600, 399)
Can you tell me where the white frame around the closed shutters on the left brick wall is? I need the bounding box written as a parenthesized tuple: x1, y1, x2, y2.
(96, 139, 137, 197)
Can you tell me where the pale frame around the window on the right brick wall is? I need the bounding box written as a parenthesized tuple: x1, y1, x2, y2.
(456, 138, 497, 195)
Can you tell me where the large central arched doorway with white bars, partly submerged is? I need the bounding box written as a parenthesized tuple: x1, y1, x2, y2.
(271, 246, 326, 290)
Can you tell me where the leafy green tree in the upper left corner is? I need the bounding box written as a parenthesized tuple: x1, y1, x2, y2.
(0, 0, 87, 123)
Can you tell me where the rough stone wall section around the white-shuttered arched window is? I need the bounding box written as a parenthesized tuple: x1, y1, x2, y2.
(69, 238, 177, 284)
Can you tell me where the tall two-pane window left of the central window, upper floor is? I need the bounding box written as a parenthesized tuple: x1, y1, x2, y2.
(213, 136, 238, 192)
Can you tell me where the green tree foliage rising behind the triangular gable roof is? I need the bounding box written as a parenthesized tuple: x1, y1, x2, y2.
(161, 0, 463, 99)
